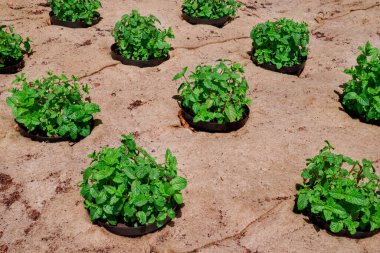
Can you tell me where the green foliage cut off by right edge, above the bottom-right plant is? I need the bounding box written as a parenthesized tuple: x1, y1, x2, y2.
(342, 42, 380, 122)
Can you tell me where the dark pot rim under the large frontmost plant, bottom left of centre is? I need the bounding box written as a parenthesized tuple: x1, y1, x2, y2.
(97, 217, 171, 237)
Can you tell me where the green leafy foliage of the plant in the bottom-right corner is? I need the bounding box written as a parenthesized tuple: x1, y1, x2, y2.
(297, 141, 380, 234)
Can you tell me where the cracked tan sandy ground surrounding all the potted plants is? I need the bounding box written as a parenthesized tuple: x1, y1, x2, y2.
(0, 0, 380, 253)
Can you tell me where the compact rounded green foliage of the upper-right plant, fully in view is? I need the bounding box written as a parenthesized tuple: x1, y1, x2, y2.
(251, 18, 309, 69)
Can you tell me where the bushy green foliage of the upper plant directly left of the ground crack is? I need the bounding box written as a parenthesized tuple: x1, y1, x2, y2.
(112, 10, 174, 61)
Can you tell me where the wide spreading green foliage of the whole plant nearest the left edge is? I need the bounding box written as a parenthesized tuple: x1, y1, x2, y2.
(7, 72, 100, 140)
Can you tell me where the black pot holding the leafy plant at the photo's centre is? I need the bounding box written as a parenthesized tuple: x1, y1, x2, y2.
(181, 106, 250, 133)
